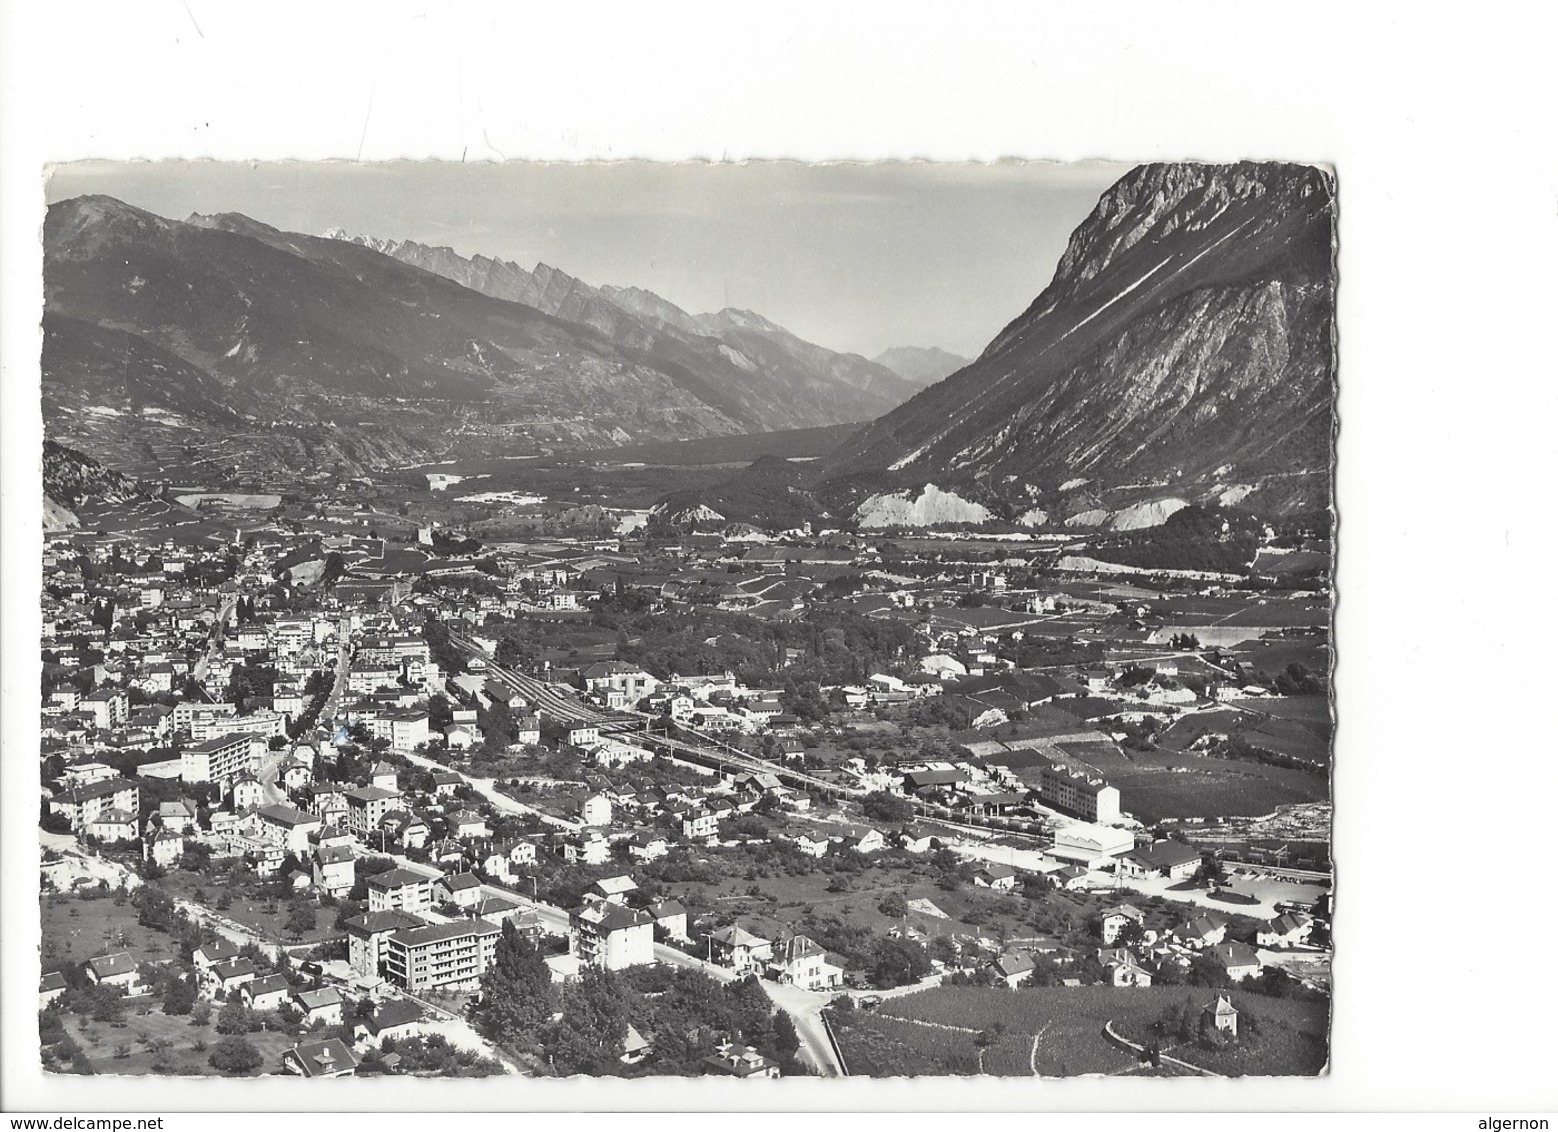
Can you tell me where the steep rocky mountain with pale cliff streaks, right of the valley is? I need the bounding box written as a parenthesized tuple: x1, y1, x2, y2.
(824, 163, 1335, 515)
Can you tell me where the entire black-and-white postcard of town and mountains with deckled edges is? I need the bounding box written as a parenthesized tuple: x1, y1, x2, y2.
(30, 160, 1346, 1077)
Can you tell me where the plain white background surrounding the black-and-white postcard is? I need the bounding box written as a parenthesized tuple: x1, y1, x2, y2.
(0, 0, 1558, 1126)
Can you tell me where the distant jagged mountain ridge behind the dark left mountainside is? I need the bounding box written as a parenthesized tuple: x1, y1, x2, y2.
(326, 229, 915, 431)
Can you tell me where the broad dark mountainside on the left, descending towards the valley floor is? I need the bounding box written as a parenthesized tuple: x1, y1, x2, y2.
(44, 196, 909, 478)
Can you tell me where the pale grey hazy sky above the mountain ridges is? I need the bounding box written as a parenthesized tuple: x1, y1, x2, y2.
(48, 162, 1128, 357)
